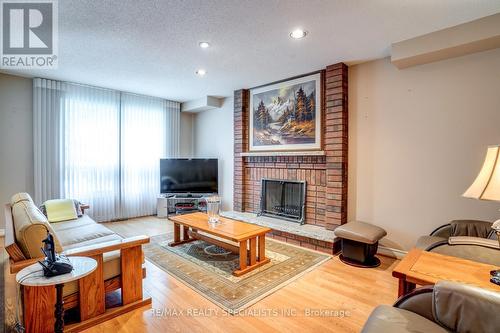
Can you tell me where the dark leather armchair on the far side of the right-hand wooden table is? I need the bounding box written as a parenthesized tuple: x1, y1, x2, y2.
(416, 220, 500, 266)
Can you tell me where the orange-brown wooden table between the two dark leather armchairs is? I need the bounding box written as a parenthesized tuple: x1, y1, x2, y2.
(392, 249, 500, 297)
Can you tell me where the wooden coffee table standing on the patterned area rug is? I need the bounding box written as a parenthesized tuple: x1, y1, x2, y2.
(168, 212, 271, 276)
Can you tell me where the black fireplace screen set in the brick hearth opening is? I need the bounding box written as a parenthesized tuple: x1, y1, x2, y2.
(259, 178, 306, 224)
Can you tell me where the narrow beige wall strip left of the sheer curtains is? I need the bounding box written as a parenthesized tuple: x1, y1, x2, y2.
(0, 74, 34, 228)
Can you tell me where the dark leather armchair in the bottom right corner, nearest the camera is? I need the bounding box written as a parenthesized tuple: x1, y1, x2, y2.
(361, 281, 500, 333)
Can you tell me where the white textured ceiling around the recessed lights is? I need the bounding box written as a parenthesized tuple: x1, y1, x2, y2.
(1, 0, 500, 101)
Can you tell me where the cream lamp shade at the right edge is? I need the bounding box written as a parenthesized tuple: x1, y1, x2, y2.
(463, 145, 500, 201)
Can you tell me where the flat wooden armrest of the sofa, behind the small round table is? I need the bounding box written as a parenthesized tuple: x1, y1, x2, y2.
(10, 236, 149, 274)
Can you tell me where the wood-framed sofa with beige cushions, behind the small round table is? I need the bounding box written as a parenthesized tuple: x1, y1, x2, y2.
(5, 193, 151, 332)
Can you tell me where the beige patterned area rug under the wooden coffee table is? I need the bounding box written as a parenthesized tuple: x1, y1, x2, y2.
(143, 233, 331, 314)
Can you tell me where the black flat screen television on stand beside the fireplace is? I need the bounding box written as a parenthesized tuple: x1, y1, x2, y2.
(160, 158, 219, 194)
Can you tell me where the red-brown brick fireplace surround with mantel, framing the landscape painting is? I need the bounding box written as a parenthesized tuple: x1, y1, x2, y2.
(233, 63, 348, 252)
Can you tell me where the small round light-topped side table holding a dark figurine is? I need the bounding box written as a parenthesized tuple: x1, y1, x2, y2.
(16, 257, 97, 333)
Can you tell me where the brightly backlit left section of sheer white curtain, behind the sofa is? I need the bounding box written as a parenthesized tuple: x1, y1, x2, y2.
(61, 84, 120, 221)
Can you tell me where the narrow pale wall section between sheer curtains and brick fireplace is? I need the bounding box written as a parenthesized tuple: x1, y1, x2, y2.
(193, 98, 234, 210)
